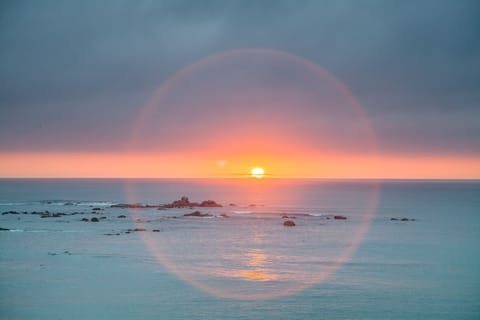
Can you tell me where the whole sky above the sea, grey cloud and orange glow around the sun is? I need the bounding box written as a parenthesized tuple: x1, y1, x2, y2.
(0, 0, 480, 178)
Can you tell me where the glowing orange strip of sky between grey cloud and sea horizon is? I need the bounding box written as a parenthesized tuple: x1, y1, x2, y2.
(0, 152, 480, 179)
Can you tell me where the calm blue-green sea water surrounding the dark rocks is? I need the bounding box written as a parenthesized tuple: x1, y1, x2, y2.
(0, 179, 480, 319)
